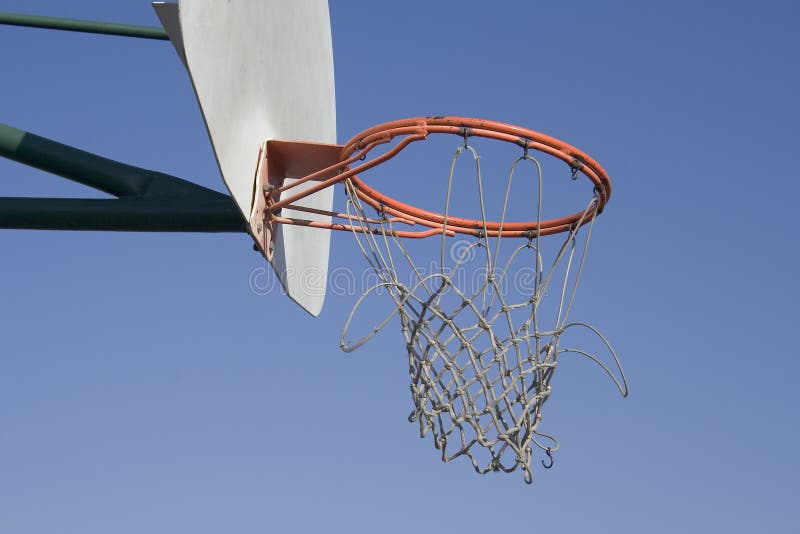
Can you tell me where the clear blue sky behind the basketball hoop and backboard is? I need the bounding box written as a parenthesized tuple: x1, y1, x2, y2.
(0, 0, 800, 534)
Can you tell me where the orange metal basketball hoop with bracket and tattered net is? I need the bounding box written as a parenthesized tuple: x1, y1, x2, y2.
(251, 117, 628, 483)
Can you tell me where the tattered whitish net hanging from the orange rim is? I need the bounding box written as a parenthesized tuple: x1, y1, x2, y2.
(342, 139, 627, 483)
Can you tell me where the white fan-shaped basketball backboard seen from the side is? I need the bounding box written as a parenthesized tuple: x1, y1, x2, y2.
(153, 0, 336, 315)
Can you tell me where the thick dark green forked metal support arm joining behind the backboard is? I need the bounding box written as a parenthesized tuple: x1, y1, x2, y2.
(0, 124, 246, 233)
